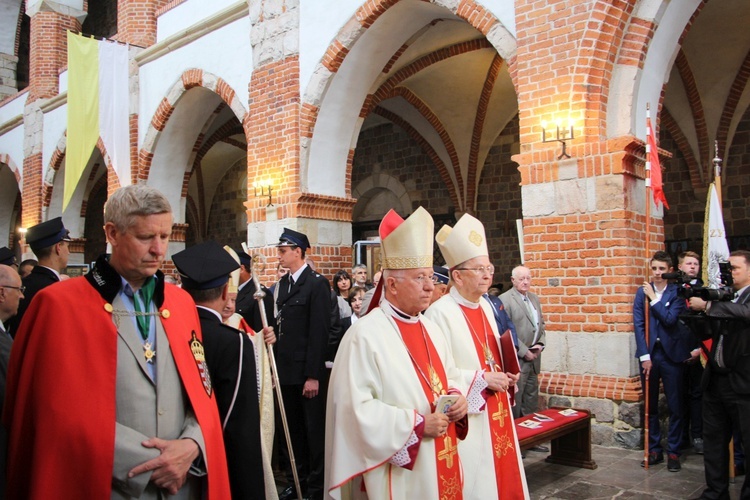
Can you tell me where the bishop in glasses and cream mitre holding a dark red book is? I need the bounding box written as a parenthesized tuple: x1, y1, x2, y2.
(425, 214, 529, 500)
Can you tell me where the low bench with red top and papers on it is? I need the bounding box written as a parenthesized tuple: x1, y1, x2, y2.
(515, 408, 597, 469)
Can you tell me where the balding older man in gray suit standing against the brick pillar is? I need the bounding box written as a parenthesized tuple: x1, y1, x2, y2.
(500, 266, 545, 420)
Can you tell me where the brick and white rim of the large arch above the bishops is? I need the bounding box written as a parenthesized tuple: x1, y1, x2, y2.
(300, 0, 518, 201)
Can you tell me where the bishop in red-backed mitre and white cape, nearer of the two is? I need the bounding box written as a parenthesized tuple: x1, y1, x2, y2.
(325, 207, 467, 500)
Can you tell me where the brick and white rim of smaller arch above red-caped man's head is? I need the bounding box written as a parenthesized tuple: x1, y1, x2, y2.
(137, 68, 248, 182)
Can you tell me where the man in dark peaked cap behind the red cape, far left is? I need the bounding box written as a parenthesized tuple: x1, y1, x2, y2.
(8, 217, 70, 335)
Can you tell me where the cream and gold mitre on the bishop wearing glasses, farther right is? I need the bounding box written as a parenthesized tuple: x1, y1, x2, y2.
(435, 214, 489, 269)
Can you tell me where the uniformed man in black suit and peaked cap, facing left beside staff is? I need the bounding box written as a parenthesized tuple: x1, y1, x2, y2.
(275, 228, 331, 500)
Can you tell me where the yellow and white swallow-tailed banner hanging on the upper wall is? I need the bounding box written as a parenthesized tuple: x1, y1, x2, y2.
(62, 32, 130, 210)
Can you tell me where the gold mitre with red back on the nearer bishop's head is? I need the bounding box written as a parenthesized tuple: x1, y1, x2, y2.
(379, 207, 435, 269)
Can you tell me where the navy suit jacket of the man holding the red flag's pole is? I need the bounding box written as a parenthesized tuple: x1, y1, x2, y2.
(633, 284, 690, 363)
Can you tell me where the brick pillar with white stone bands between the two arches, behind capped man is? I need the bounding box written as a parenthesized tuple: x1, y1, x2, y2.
(243, 0, 354, 281)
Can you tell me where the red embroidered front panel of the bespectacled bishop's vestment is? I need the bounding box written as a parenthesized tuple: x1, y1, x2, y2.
(460, 306, 524, 500)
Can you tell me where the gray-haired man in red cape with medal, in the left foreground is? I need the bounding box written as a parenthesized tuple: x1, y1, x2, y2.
(3, 185, 230, 499)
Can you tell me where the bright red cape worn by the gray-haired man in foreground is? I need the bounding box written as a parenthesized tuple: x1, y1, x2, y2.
(3, 278, 231, 499)
